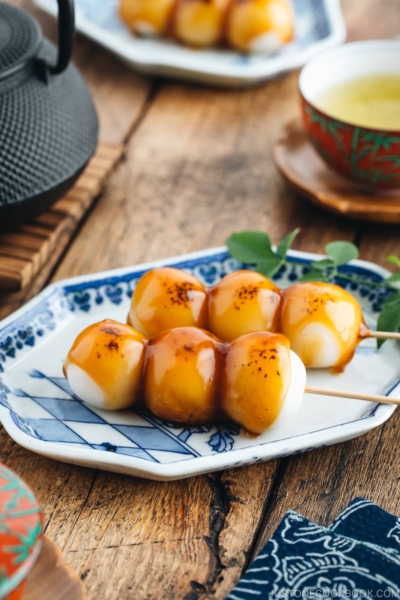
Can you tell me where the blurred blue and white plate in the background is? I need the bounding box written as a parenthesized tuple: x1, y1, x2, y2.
(34, 0, 346, 86)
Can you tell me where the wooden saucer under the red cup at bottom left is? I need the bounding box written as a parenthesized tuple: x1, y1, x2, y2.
(22, 536, 86, 600)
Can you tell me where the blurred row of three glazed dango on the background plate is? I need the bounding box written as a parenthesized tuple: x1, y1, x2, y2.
(119, 0, 294, 54)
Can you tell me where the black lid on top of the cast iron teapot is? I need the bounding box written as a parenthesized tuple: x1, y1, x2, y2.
(0, 2, 42, 80)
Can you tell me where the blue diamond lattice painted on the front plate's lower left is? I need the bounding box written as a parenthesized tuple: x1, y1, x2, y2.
(0, 370, 239, 463)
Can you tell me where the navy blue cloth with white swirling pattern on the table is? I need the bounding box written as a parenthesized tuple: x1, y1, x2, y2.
(227, 498, 400, 600)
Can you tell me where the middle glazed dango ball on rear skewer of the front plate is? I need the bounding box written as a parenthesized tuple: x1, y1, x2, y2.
(208, 270, 281, 342)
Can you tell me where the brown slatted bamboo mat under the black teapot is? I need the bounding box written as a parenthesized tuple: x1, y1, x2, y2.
(0, 143, 123, 292)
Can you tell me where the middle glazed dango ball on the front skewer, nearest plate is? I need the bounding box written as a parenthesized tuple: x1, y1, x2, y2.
(144, 327, 220, 425)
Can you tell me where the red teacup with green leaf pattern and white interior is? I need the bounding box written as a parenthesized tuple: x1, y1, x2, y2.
(299, 40, 400, 189)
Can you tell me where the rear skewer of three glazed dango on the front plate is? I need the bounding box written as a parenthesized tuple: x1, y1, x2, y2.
(128, 267, 400, 372)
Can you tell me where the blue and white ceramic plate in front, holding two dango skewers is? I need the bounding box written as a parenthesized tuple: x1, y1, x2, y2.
(0, 248, 400, 479)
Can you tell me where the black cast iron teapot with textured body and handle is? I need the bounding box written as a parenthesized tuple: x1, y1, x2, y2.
(0, 0, 98, 230)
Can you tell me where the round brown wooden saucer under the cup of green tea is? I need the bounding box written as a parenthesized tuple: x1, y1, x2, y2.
(274, 121, 400, 223)
